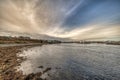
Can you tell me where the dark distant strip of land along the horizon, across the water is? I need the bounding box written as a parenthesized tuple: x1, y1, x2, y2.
(0, 36, 120, 45)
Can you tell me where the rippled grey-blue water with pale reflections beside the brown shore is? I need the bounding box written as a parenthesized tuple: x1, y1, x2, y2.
(18, 44, 120, 80)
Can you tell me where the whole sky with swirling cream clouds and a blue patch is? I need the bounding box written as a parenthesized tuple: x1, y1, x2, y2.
(0, 0, 120, 40)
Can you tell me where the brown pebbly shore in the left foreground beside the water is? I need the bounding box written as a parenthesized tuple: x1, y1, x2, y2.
(0, 44, 50, 80)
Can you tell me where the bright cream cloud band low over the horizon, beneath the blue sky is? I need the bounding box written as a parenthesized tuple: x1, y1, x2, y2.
(44, 24, 120, 40)
